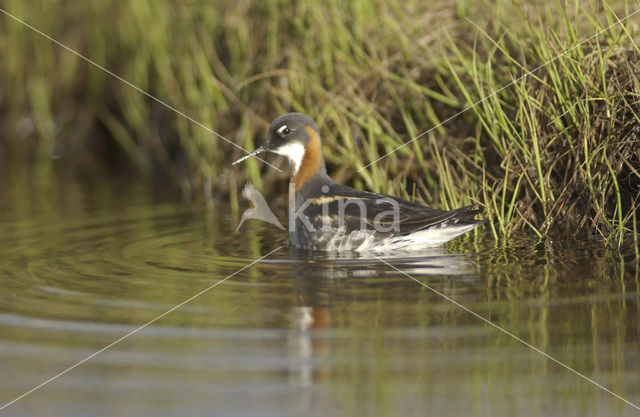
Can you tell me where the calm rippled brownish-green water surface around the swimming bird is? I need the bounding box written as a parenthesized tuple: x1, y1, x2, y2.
(0, 169, 640, 416)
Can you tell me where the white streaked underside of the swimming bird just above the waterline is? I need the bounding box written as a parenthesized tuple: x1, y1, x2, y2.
(293, 224, 477, 253)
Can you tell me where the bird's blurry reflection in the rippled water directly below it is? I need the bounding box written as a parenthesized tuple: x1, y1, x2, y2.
(287, 247, 476, 388)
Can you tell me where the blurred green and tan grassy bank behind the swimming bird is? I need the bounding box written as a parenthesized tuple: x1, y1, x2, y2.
(0, 0, 640, 242)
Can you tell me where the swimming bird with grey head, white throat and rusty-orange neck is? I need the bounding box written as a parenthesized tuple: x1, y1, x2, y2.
(233, 113, 482, 252)
